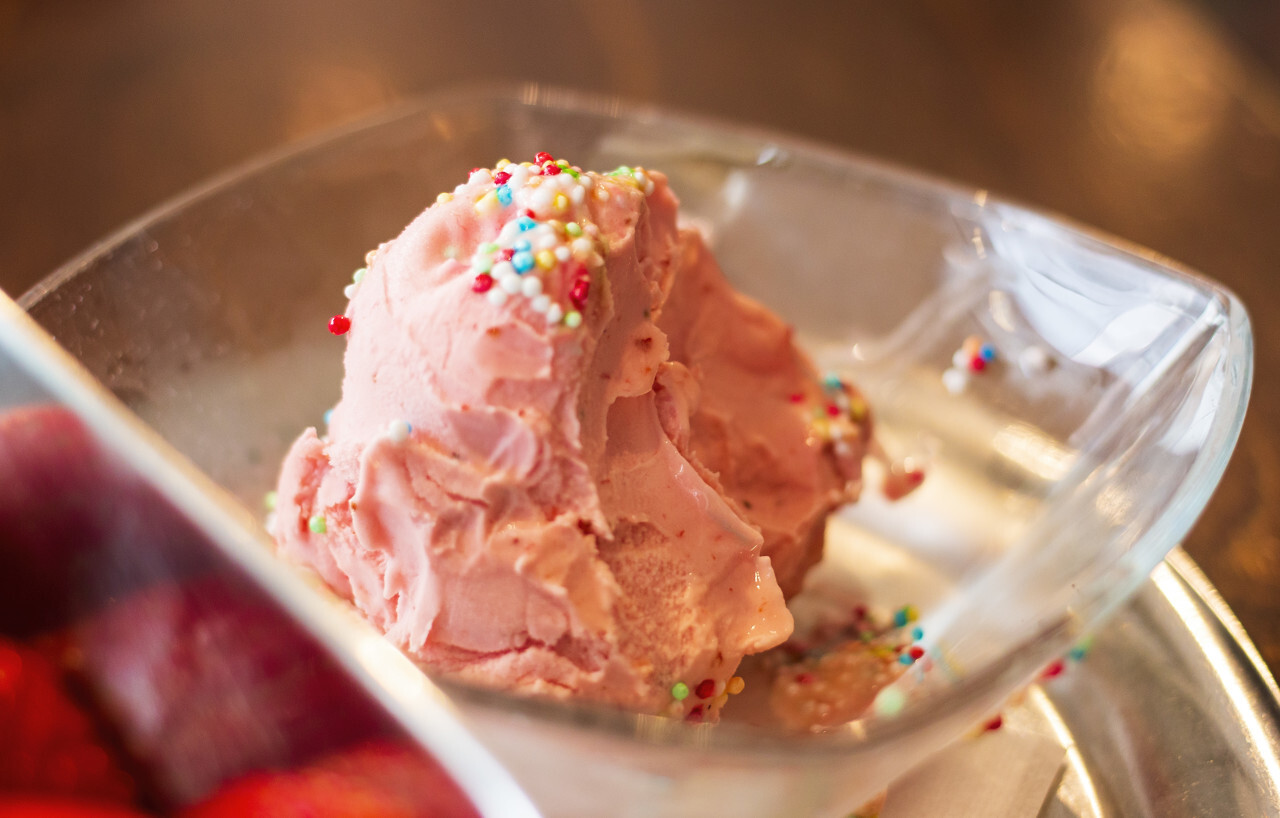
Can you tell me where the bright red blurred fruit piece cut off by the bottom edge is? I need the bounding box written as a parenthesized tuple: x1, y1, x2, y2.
(179, 744, 479, 818)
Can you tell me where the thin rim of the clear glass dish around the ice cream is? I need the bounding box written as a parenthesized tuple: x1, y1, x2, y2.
(18, 83, 1253, 755)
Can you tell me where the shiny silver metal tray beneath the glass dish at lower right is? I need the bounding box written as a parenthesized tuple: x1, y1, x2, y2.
(1034, 549, 1280, 818)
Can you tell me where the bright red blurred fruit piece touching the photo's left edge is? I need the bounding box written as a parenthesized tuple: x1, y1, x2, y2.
(0, 639, 133, 803)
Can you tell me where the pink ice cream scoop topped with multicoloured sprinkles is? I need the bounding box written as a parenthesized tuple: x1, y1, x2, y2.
(275, 154, 870, 721)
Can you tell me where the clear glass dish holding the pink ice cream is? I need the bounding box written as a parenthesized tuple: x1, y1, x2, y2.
(10, 86, 1252, 815)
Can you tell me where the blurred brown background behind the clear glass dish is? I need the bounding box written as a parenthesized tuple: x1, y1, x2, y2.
(0, 0, 1280, 670)
